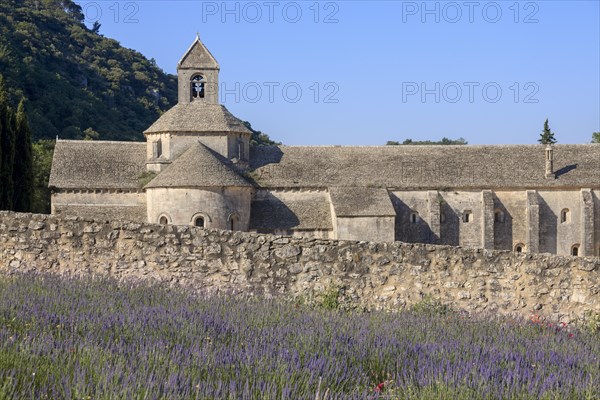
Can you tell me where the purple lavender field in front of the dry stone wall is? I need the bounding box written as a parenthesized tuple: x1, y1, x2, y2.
(0, 275, 600, 400)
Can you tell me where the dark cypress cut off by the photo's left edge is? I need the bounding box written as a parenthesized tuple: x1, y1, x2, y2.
(0, 76, 15, 210)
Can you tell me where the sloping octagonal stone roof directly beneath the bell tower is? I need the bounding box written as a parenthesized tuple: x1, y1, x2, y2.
(144, 101, 251, 135)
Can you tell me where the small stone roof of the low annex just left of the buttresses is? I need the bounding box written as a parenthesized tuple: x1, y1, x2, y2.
(329, 186, 396, 217)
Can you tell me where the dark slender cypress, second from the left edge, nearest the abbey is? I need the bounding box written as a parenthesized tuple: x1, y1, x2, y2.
(13, 99, 33, 212)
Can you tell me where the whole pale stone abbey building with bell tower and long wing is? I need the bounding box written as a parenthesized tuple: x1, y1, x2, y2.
(50, 39, 600, 256)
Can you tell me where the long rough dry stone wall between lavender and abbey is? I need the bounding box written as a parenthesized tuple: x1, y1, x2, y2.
(0, 212, 600, 320)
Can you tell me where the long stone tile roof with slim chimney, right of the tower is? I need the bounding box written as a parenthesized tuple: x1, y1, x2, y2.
(250, 144, 600, 190)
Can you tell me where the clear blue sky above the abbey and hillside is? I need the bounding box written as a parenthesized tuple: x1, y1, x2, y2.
(79, 0, 600, 145)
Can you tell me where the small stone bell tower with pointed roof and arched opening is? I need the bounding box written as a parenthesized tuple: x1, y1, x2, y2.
(177, 35, 220, 104)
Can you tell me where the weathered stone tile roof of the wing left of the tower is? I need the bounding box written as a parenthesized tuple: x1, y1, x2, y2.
(48, 140, 146, 189)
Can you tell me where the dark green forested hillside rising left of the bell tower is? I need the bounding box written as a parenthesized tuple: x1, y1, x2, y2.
(0, 0, 177, 140)
